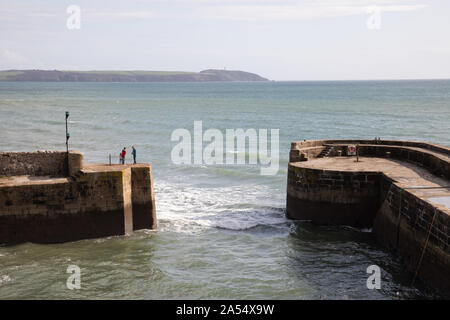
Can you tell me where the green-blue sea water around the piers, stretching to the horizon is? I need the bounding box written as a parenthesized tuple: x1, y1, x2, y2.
(0, 80, 450, 299)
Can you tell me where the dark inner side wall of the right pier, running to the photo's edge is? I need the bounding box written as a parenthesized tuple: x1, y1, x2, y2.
(373, 177, 450, 294)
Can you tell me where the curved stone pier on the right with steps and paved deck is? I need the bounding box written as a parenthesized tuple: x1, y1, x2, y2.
(286, 140, 450, 296)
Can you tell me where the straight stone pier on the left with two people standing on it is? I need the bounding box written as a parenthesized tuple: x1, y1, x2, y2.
(0, 151, 156, 244)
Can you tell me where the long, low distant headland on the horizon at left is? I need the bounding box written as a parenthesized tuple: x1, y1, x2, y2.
(0, 69, 268, 82)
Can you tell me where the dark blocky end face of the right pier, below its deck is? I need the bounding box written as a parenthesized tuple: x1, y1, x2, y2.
(286, 165, 380, 228)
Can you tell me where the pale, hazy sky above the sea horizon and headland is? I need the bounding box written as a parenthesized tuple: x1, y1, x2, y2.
(0, 0, 450, 80)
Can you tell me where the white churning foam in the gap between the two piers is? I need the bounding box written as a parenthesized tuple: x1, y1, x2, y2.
(155, 181, 286, 233)
